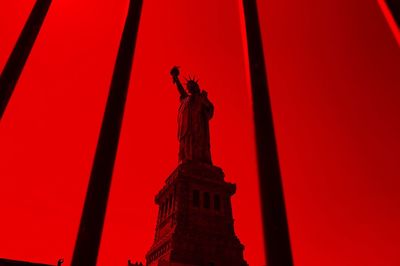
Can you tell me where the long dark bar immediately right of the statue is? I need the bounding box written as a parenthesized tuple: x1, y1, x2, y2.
(243, 0, 293, 266)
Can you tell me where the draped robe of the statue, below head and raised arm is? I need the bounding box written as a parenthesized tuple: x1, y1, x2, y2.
(178, 93, 214, 164)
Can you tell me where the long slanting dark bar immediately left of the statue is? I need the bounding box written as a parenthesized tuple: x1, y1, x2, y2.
(71, 0, 142, 266)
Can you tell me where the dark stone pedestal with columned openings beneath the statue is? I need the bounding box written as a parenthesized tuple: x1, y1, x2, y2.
(146, 163, 248, 266)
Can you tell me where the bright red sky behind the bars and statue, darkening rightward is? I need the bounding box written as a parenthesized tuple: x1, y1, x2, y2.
(0, 0, 400, 266)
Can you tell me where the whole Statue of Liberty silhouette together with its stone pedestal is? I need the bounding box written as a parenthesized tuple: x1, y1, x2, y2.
(146, 68, 248, 266)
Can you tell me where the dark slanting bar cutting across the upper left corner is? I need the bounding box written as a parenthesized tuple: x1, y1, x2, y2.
(0, 0, 51, 120)
